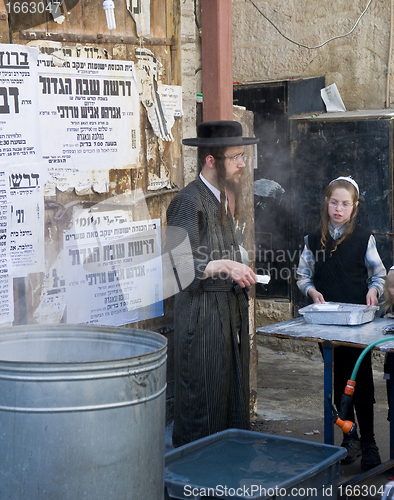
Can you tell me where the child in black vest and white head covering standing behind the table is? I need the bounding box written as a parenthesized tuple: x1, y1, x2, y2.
(297, 176, 386, 470)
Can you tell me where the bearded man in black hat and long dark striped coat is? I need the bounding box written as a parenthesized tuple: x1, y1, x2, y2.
(167, 121, 258, 446)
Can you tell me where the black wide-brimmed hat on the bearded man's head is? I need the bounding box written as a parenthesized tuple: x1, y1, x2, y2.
(182, 120, 259, 148)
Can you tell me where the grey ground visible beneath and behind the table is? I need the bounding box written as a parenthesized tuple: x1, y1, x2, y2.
(252, 336, 394, 499)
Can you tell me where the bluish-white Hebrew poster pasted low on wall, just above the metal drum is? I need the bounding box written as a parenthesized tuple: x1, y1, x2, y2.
(64, 210, 163, 326)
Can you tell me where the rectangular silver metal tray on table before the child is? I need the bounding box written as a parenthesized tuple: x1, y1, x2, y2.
(298, 302, 379, 325)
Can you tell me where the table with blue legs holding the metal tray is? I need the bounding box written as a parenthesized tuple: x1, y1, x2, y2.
(256, 317, 394, 459)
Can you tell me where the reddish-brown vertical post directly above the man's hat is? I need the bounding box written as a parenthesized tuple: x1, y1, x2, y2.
(201, 0, 233, 121)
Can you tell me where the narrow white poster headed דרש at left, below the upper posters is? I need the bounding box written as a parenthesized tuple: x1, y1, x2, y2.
(7, 163, 47, 278)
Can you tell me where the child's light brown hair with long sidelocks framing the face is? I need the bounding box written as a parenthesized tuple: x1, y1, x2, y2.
(320, 179, 358, 256)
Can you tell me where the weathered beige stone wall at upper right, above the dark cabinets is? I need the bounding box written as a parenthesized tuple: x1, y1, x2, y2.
(232, 0, 394, 111)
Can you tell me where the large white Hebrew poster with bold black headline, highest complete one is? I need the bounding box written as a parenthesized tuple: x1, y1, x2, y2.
(38, 55, 140, 172)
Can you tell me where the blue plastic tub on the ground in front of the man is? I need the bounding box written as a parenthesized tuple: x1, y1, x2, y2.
(165, 429, 346, 500)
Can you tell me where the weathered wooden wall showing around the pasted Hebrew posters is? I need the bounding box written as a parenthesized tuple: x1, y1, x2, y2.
(0, 0, 196, 329)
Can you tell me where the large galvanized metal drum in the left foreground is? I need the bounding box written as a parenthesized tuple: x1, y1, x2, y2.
(0, 325, 167, 500)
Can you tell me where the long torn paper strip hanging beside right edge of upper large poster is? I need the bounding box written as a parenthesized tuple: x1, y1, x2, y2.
(135, 48, 174, 141)
